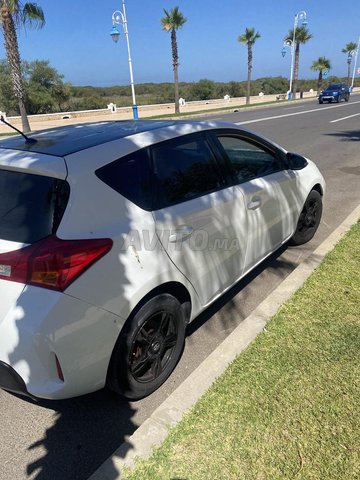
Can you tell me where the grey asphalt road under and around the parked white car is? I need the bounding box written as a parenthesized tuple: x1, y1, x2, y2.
(0, 95, 360, 480)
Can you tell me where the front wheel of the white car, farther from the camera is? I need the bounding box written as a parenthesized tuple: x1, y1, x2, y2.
(289, 190, 323, 245)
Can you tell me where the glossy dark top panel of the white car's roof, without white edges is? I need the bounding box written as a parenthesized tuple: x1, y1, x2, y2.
(0, 120, 194, 157)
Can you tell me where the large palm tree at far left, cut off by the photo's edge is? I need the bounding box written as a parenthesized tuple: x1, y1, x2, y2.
(0, 0, 45, 132)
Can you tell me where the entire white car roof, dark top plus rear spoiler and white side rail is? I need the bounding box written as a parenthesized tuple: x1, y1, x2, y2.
(0, 120, 285, 178)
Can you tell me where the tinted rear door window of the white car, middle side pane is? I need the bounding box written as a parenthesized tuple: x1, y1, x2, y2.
(151, 135, 223, 208)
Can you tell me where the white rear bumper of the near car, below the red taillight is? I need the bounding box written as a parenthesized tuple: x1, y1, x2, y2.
(0, 282, 124, 399)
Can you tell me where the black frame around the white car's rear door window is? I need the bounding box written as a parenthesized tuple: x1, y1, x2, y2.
(148, 131, 228, 211)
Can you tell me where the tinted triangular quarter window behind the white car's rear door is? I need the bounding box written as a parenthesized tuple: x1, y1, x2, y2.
(95, 149, 152, 210)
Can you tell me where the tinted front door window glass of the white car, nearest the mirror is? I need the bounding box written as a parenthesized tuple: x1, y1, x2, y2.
(217, 135, 281, 183)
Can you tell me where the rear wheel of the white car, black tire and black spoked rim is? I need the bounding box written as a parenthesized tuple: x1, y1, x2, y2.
(107, 294, 186, 400)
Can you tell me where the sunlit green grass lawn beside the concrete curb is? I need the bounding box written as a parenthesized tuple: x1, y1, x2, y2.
(125, 222, 360, 480)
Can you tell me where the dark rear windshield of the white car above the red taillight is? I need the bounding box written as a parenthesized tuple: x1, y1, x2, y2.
(0, 169, 70, 243)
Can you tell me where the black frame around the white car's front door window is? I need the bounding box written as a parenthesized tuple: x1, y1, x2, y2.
(208, 128, 288, 186)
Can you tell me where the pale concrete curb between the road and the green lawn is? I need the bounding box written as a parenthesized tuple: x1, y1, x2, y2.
(89, 205, 360, 480)
